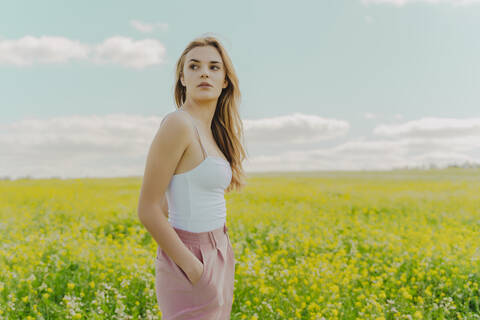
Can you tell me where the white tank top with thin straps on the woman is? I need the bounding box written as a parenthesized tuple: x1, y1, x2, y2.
(166, 109, 232, 232)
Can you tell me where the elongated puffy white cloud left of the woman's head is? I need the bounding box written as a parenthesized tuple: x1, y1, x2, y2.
(0, 36, 166, 69)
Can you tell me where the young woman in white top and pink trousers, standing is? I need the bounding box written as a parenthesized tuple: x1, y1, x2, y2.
(138, 37, 245, 320)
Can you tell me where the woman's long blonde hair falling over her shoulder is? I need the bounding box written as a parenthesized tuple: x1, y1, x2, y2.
(174, 36, 246, 192)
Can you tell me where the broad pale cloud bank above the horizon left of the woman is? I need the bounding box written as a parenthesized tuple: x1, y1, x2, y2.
(0, 114, 161, 177)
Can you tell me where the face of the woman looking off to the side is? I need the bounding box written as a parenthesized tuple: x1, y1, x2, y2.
(180, 46, 228, 100)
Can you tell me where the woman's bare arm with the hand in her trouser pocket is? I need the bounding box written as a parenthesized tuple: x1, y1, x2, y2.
(137, 112, 203, 279)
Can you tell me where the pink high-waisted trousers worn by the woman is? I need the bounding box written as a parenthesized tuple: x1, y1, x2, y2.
(155, 224, 236, 320)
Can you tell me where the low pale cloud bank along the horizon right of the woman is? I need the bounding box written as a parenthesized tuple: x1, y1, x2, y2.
(244, 139, 480, 172)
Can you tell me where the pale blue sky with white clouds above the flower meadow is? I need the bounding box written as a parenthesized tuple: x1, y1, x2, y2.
(0, 0, 480, 179)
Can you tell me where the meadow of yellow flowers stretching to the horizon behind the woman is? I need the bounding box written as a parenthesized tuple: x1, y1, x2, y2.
(0, 168, 480, 320)
